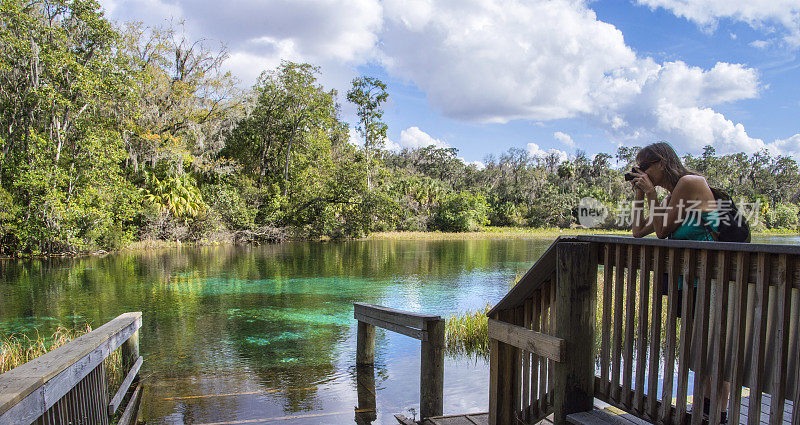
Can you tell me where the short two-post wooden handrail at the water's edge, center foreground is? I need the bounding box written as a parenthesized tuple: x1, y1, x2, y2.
(353, 303, 444, 421)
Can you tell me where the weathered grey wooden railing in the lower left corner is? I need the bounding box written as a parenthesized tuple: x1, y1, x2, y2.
(0, 312, 142, 425)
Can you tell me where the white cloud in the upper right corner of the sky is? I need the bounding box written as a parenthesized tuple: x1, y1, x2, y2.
(637, 0, 800, 47)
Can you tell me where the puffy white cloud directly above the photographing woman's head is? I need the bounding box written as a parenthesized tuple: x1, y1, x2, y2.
(586, 59, 765, 153)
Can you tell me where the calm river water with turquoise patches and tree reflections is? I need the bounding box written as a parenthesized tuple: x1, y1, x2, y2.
(0, 234, 800, 424)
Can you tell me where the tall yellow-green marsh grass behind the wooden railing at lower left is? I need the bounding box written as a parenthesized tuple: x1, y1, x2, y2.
(0, 323, 122, 391)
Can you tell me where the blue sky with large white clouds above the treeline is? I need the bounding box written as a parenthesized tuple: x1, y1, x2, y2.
(101, 0, 800, 162)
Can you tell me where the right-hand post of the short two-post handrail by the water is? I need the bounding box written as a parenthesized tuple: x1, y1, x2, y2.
(419, 319, 444, 418)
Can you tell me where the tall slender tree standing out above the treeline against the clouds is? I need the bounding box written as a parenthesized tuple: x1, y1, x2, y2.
(347, 77, 389, 190)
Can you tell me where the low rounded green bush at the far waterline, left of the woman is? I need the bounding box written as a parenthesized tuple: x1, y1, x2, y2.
(433, 191, 489, 232)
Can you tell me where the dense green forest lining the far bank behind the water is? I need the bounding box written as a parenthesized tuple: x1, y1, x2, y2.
(0, 0, 800, 256)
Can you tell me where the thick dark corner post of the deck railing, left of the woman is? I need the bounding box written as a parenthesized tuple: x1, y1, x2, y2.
(553, 242, 597, 425)
